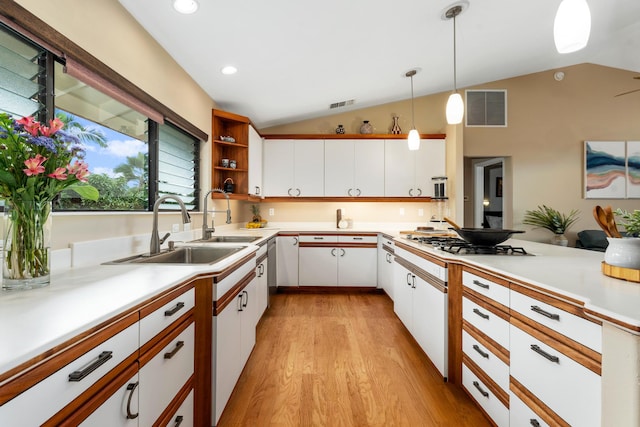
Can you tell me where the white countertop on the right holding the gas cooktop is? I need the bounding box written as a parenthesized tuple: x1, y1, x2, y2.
(396, 237, 640, 328)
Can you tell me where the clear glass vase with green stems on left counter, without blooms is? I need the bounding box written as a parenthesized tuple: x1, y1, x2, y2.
(2, 201, 51, 290)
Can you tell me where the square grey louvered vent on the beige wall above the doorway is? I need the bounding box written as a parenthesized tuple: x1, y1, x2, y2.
(465, 90, 507, 127)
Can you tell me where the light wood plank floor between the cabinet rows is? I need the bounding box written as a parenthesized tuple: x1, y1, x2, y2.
(218, 294, 490, 427)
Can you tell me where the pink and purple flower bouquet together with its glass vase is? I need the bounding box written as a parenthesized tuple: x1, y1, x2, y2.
(0, 113, 98, 289)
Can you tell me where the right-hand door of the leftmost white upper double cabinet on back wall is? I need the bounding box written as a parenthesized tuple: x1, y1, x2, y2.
(292, 139, 324, 197)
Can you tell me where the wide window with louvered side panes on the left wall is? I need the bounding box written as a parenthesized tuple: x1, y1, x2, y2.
(0, 24, 200, 211)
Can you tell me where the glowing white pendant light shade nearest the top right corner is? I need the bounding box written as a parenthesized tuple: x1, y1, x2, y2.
(553, 0, 591, 53)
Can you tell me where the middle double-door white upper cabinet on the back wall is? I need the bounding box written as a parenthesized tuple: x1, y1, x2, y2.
(324, 139, 384, 197)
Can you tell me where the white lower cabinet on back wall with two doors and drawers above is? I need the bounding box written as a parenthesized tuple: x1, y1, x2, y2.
(299, 235, 378, 287)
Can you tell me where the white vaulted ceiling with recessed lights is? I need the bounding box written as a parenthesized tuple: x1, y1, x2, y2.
(120, 0, 640, 128)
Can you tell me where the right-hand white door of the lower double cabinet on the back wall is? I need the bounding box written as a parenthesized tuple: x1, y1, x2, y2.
(336, 248, 378, 287)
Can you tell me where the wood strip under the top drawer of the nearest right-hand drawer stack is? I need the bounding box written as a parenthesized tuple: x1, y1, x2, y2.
(511, 311, 602, 375)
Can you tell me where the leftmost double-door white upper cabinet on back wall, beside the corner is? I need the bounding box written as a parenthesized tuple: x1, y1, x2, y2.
(263, 139, 324, 197)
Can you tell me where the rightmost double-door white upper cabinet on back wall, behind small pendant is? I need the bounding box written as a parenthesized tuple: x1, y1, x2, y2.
(384, 139, 445, 197)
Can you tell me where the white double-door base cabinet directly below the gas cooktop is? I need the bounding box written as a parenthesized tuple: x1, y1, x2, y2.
(393, 247, 448, 378)
